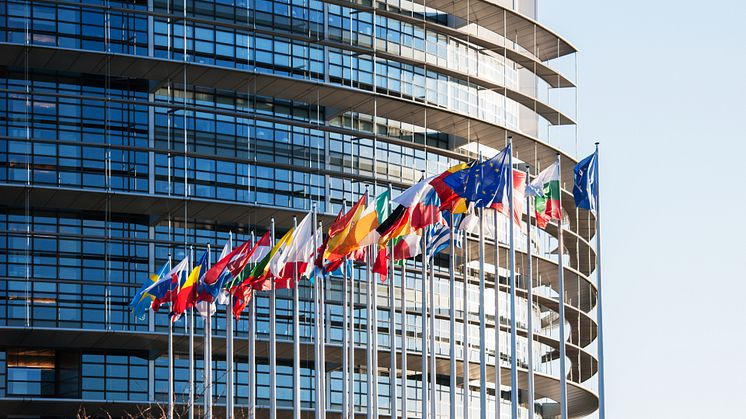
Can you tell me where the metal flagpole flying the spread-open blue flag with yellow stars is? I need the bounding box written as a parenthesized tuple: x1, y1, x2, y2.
(506, 137, 518, 419)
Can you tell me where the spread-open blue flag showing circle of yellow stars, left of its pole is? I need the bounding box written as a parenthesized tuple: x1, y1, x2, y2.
(443, 146, 511, 208)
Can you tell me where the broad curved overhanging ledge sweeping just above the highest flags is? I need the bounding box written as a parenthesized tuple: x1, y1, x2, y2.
(0, 43, 574, 185)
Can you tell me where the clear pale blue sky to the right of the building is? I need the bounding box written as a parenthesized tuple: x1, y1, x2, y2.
(539, 0, 746, 419)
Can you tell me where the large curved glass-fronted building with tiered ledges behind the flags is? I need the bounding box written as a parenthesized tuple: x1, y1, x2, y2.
(0, 0, 598, 418)
